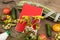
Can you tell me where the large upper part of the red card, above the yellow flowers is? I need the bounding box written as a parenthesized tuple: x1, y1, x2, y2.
(19, 4, 43, 18)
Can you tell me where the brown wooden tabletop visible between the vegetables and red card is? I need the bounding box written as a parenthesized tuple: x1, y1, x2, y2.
(0, 0, 60, 40)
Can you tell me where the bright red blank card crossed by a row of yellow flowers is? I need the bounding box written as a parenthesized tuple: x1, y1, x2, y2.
(16, 4, 43, 32)
